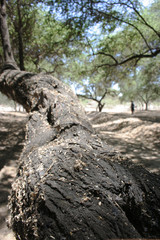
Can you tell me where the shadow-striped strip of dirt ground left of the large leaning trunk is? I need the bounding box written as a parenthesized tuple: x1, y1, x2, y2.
(0, 113, 27, 240)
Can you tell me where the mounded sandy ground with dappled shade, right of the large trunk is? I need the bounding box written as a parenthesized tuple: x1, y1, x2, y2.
(88, 111, 160, 173)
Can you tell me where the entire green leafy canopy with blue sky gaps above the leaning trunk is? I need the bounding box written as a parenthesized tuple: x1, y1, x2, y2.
(1, 0, 160, 109)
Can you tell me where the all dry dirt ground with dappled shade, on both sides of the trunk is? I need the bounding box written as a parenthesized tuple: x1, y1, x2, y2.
(0, 111, 160, 240)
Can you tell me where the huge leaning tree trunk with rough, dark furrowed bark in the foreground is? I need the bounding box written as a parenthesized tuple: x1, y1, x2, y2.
(0, 70, 160, 240)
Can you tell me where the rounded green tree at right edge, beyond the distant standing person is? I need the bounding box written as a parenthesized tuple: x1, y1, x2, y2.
(119, 57, 160, 110)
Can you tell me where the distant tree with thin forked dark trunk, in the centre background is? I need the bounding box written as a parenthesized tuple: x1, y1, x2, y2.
(64, 50, 116, 112)
